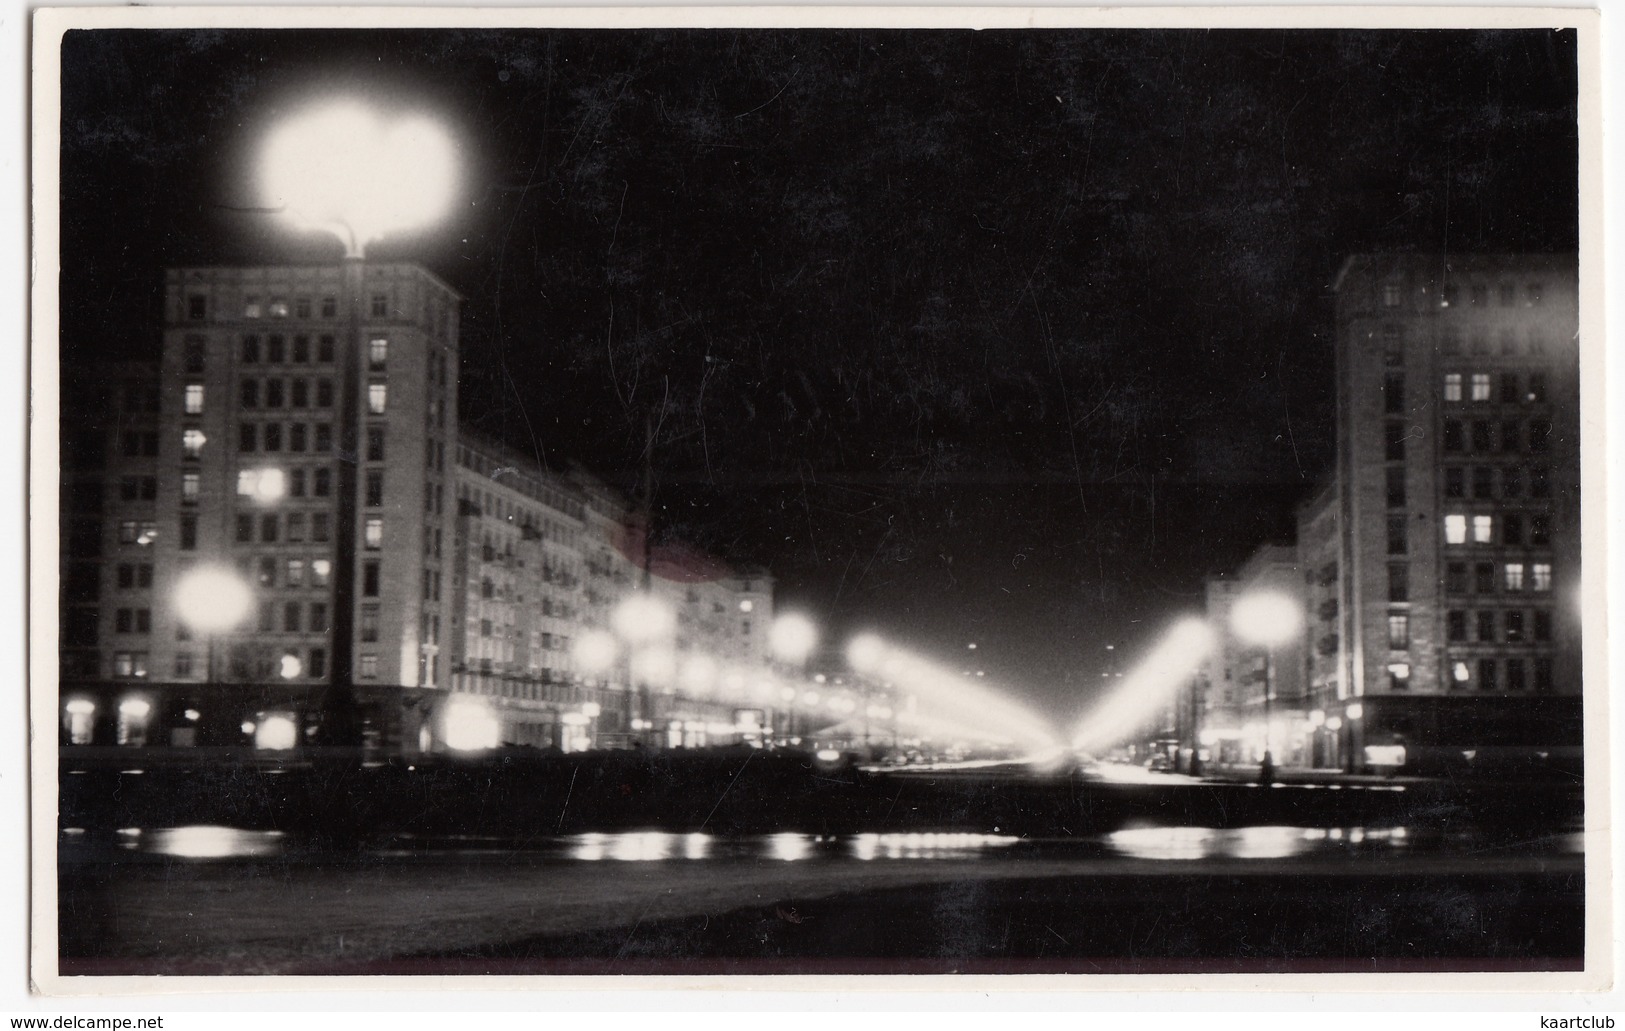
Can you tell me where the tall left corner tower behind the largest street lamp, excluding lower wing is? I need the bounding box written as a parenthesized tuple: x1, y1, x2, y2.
(65, 263, 458, 743)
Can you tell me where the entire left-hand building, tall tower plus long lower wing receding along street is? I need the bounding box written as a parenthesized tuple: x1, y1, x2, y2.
(60, 263, 796, 751)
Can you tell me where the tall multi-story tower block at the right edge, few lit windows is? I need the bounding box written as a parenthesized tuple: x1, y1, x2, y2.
(1336, 255, 1581, 758)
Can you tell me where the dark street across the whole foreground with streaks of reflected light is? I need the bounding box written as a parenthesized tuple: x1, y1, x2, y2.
(59, 754, 1583, 974)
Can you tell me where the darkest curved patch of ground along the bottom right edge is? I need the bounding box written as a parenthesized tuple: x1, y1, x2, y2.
(412, 873, 1584, 974)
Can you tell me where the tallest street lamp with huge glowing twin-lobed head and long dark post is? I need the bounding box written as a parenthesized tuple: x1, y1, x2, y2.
(260, 99, 457, 745)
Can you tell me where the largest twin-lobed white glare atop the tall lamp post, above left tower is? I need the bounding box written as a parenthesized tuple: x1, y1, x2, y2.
(260, 101, 457, 257)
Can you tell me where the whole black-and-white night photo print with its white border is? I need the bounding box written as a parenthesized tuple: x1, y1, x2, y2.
(29, 8, 1612, 994)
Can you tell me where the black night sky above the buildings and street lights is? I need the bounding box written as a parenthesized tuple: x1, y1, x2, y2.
(62, 24, 1578, 717)
